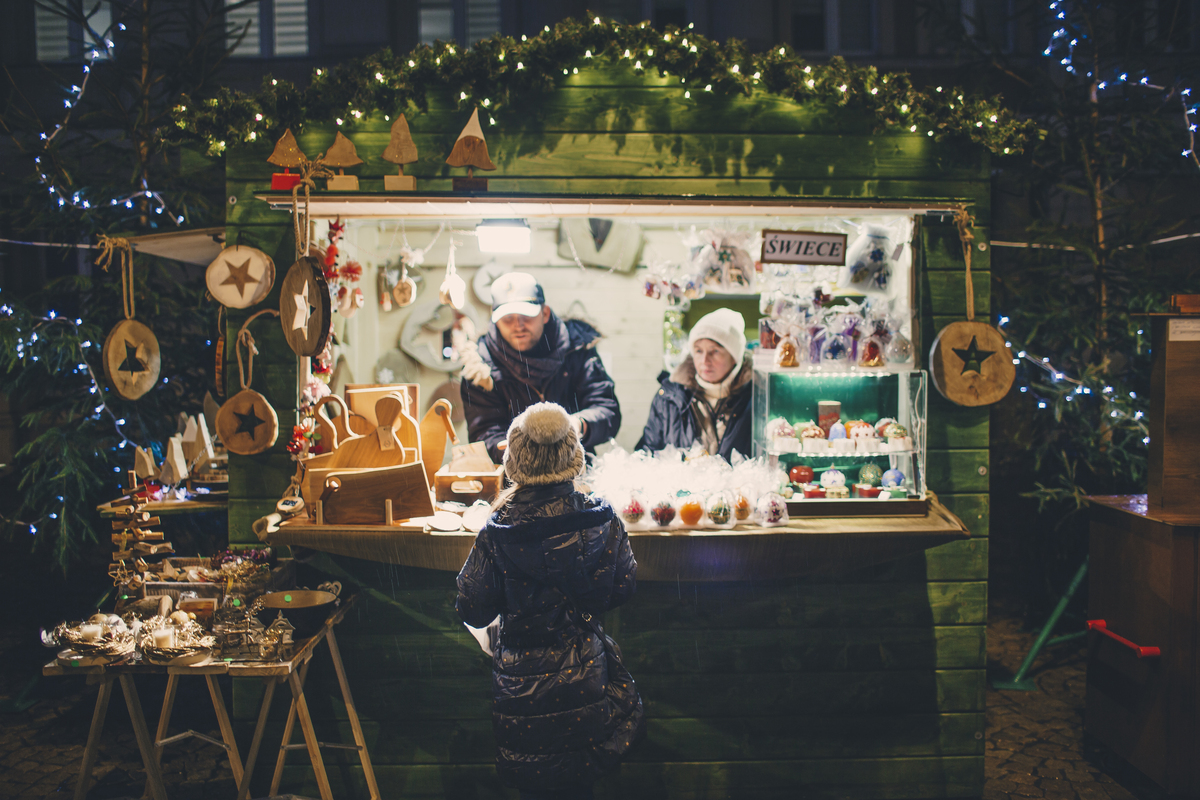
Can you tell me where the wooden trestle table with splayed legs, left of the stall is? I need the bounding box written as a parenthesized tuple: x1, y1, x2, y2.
(42, 597, 379, 800)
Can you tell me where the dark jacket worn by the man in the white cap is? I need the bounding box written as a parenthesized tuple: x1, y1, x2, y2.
(461, 314, 620, 464)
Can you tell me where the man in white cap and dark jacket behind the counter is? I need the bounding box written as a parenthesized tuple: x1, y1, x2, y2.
(462, 272, 620, 464)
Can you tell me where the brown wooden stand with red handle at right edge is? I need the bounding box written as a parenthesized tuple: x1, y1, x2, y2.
(1084, 496, 1200, 798)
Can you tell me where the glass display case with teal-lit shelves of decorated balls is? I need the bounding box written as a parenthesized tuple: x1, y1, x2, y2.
(754, 350, 928, 516)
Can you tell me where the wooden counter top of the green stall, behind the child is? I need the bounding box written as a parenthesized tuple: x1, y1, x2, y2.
(268, 494, 971, 581)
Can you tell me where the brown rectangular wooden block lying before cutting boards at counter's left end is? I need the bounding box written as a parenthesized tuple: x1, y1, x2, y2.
(322, 462, 433, 525)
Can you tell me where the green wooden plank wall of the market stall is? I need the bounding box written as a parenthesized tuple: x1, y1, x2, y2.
(227, 67, 990, 799)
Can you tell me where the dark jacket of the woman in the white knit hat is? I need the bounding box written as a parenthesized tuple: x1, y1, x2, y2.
(635, 354, 754, 461)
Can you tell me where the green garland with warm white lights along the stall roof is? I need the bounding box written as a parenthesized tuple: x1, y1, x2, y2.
(163, 13, 1036, 155)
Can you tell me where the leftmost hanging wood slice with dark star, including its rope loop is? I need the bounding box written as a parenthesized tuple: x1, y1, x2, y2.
(96, 234, 162, 399)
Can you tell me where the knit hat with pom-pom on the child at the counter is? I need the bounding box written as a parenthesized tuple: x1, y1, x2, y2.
(504, 403, 583, 486)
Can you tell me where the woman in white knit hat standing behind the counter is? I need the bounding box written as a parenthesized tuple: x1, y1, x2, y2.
(637, 308, 754, 461)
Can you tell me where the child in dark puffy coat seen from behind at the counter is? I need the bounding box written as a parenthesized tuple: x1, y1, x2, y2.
(455, 403, 643, 800)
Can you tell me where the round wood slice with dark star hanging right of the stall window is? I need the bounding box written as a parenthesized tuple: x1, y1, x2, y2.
(929, 323, 1016, 405)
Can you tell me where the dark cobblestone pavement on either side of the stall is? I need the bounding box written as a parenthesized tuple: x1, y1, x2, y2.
(0, 606, 1153, 800)
